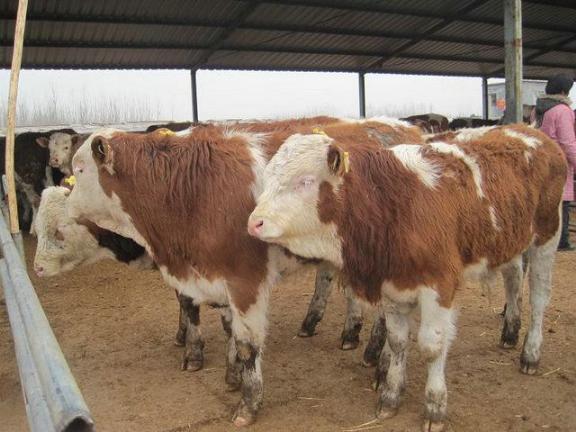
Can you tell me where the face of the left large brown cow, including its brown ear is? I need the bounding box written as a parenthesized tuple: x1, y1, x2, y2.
(68, 129, 144, 245)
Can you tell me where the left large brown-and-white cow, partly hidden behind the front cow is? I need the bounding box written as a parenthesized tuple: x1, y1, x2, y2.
(68, 116, 420, 426)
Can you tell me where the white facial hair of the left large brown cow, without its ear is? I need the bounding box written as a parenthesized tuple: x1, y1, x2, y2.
(68, 129, 147, 247)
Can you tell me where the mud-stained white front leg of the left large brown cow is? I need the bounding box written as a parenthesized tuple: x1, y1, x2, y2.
(230, 282, 271, 426)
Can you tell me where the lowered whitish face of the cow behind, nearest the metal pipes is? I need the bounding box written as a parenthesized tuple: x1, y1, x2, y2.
(34, 187, 101, 276)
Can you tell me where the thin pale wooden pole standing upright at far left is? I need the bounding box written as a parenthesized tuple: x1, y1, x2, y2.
(5, 0, 28, 234)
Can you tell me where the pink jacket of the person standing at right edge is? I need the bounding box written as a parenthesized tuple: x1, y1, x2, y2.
(540, 104, 576, 201)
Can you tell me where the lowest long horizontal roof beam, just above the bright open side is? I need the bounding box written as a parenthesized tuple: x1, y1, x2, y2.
(0, 40, 574, 70)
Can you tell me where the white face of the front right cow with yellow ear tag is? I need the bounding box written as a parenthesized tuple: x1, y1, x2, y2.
(248, 134, 347, 264)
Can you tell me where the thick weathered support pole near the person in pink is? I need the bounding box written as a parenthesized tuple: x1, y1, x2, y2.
(504, 0, 522, 123)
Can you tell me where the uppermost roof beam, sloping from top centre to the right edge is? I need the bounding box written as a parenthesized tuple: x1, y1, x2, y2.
(249, 0, 574, 33)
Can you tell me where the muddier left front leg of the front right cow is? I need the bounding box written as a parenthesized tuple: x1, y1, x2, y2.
(376, 308, 410, 419)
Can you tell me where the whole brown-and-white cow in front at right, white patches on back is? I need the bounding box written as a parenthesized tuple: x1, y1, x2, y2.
(247, 125, 566, 431)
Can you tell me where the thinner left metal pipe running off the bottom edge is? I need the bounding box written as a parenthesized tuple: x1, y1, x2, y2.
(0, 259, 56, 432)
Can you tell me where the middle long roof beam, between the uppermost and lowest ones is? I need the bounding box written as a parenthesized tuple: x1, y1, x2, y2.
(0, 13, 576, 53)
